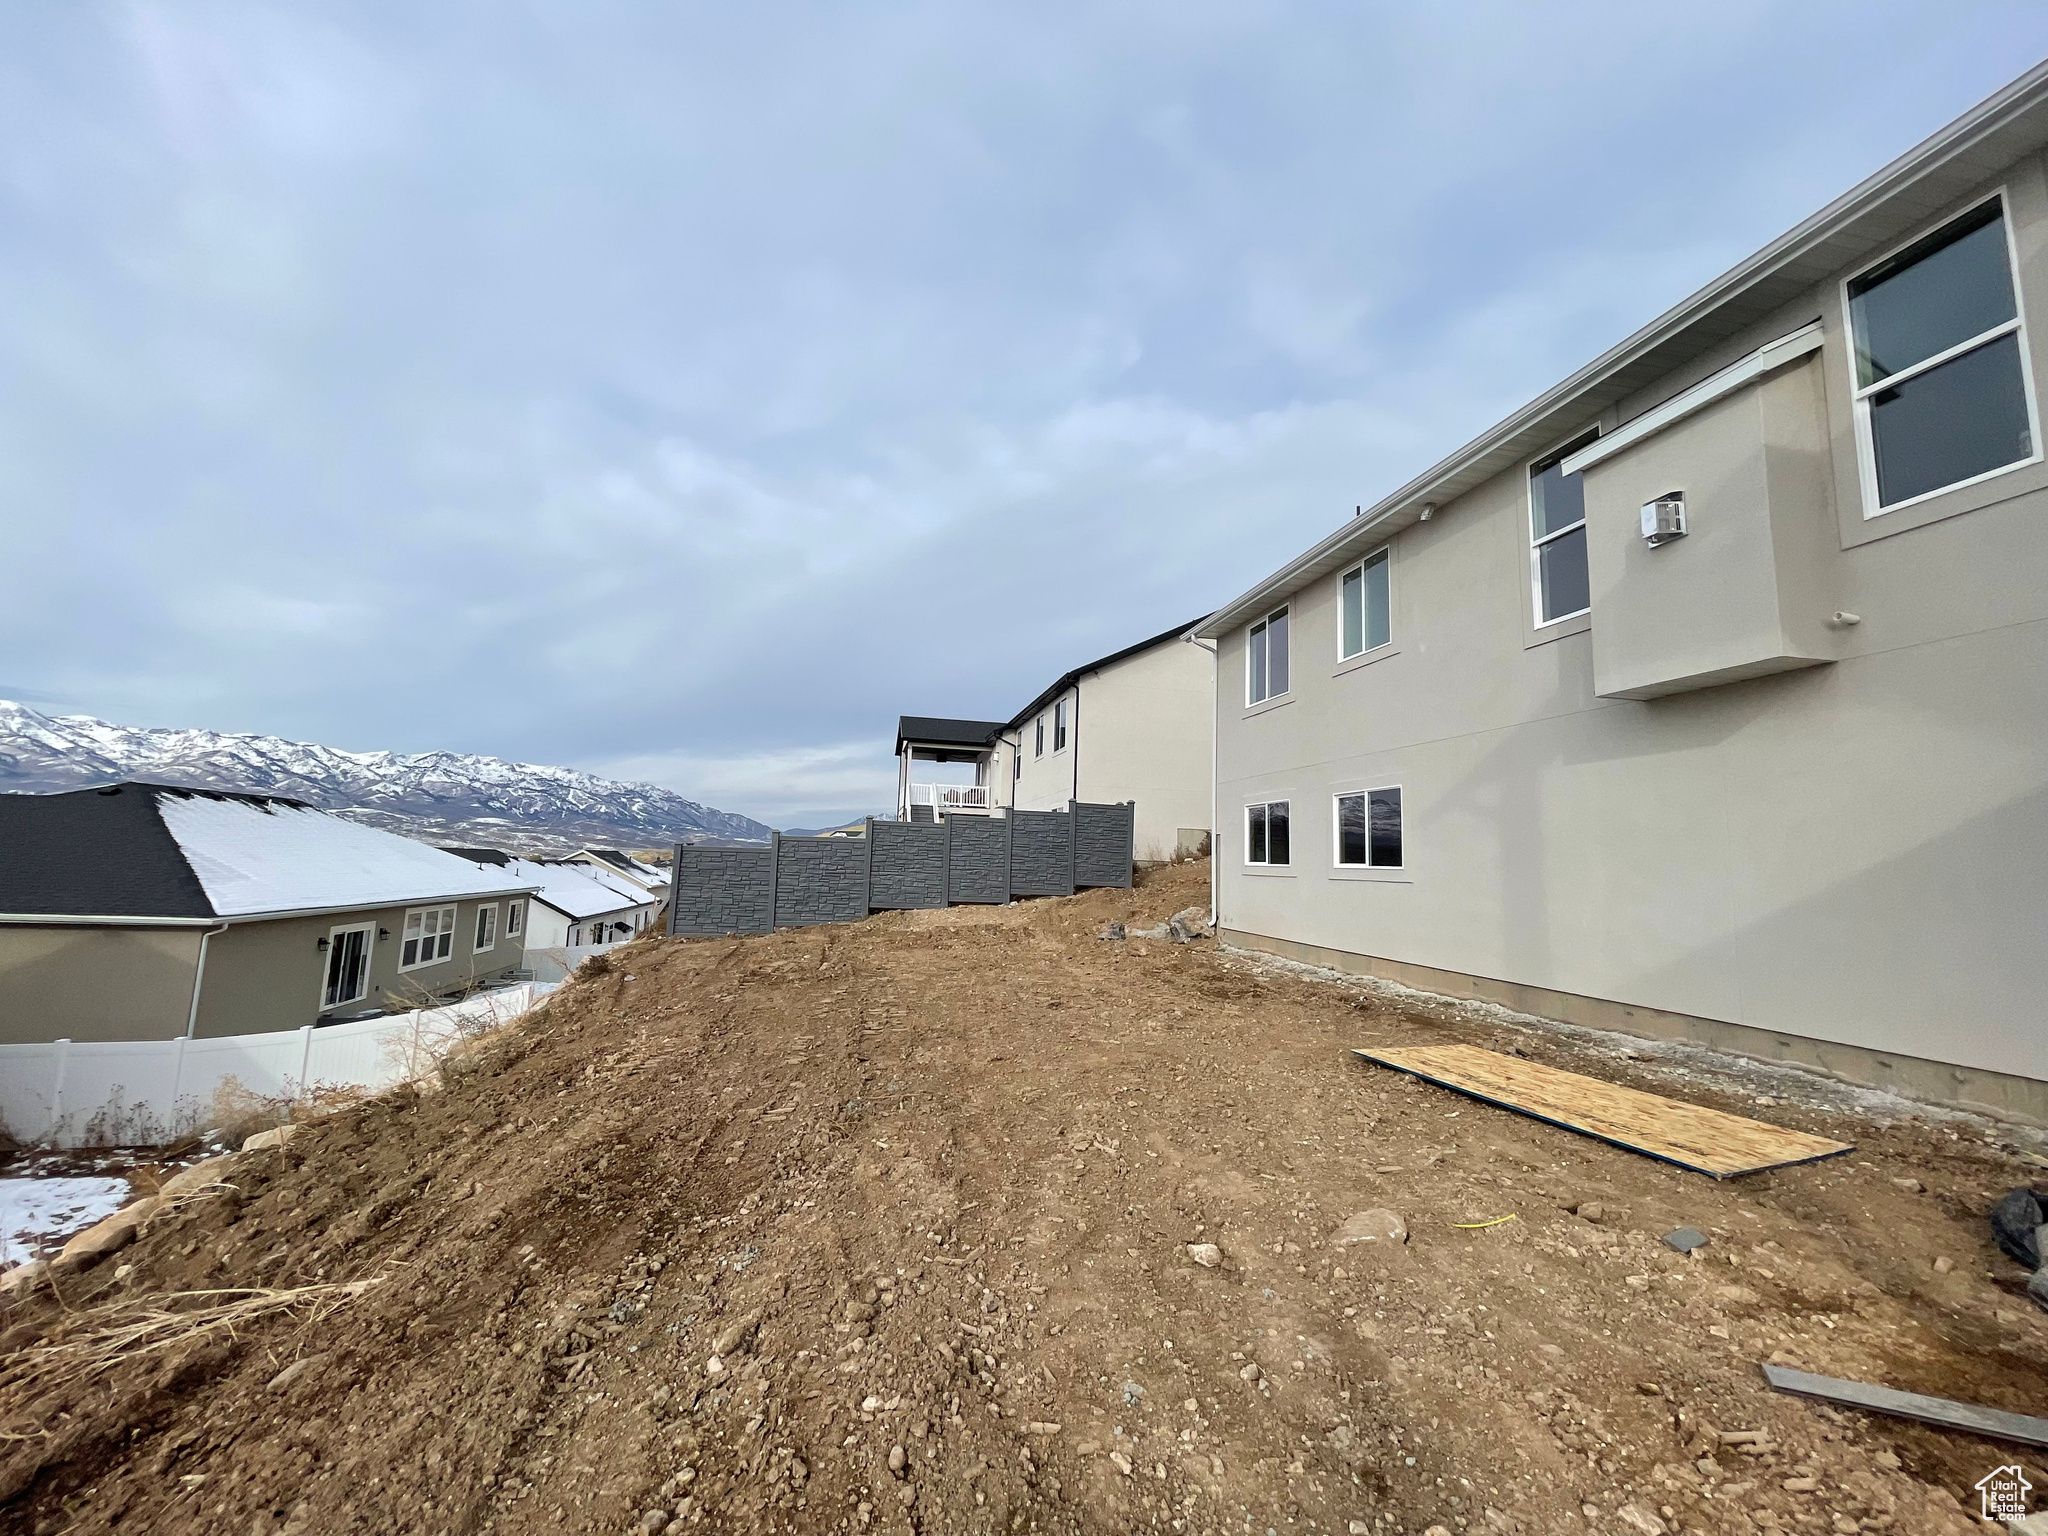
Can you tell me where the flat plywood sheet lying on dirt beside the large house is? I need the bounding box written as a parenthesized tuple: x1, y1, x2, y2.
(1352, 1044, 1853, 1180)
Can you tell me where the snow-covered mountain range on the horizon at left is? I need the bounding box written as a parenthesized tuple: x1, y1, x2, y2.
(0, 700, 768, 854)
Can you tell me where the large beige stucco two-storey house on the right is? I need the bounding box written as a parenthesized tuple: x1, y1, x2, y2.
(1196, 66, 2048, 1118)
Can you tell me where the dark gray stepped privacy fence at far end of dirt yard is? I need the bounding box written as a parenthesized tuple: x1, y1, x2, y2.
(668, 801, 1137, 938)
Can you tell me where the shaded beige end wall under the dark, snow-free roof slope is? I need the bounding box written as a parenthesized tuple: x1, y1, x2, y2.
(0, 926, 199, 1044)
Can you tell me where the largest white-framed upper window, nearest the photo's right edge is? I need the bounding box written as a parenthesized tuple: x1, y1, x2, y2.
(1843, 193, 2040, 518)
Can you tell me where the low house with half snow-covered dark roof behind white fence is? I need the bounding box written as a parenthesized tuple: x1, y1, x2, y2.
(0, 782, 532, 1042)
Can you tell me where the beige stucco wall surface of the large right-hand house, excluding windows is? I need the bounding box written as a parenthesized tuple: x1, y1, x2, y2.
(1217, 164, 2048, 1079)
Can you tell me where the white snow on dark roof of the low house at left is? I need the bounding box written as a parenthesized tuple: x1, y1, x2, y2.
(158, 791, 532, 918)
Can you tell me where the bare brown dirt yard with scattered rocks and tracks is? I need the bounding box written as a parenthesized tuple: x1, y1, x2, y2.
(0, 866, 2048, 1536)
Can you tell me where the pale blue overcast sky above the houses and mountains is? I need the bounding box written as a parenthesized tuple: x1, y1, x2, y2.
(0, 0, 2048, 825)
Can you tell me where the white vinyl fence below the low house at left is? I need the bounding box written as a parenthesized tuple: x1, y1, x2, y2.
(0, 981, 553, 1147)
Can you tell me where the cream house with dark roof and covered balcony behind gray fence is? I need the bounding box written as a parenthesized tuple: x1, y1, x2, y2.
(897, 625, 1217, 860)
